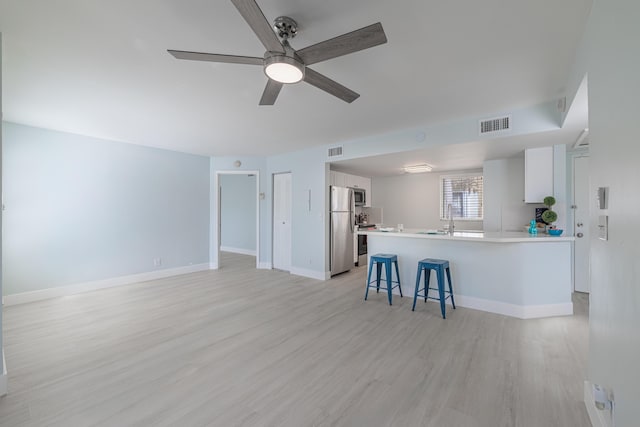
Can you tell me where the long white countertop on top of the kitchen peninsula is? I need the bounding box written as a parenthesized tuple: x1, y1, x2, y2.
(357, 229, 575, 243)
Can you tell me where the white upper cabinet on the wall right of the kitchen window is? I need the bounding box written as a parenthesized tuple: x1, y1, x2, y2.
(524, 147, 553, 203)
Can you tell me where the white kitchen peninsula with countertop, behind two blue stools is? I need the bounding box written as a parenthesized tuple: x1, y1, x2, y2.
(358, 230, 574, 319)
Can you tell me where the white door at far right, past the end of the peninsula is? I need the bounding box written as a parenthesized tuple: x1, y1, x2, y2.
(573, 157, 591, 292)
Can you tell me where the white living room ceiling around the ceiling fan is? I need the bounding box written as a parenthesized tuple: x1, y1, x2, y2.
(0, 0, 592, 155)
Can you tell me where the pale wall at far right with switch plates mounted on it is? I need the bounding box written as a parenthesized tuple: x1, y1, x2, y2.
(574, 0, 640, 427)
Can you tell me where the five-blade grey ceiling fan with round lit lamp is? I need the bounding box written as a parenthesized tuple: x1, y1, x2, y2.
(168, 0, 387, 105)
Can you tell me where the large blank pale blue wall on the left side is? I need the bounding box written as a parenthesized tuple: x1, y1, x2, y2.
(3, 123, 209, 295)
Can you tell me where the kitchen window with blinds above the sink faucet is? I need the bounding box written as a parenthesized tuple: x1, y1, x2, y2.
(440, 173, 483, 220)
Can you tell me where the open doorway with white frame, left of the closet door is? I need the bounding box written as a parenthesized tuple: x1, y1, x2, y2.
(213, 170, 260, 268)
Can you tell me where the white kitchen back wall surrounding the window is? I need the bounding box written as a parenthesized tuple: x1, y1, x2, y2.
(371, 170, 482, 230)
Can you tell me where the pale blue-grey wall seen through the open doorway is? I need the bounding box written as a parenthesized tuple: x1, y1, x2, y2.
(219, 174, 256, 255)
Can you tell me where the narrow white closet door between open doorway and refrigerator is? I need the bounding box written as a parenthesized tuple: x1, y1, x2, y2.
(273, 173, 291, 271)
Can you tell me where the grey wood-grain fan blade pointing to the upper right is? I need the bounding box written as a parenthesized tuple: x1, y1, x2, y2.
(296, 22, 387, 65)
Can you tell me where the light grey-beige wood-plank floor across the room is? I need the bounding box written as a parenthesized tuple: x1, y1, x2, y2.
(0, 254, 590, 427)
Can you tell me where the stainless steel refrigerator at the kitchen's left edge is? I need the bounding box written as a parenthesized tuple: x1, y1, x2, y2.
(329, 186, 355, 276)
